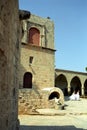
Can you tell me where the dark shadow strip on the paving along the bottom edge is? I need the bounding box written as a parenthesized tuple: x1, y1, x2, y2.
(20, 125, 85, 130)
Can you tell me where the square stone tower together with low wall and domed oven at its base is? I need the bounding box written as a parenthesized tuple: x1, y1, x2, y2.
(19, 14, 64, 113)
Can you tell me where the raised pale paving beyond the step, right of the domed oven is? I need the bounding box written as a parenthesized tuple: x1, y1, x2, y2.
(37, 98, 87, 115)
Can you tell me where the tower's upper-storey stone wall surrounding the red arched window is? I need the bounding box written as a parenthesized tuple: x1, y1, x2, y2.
(22, 14, 54, 49)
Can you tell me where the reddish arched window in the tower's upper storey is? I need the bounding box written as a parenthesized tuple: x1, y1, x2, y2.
(29, 27, 40, 46)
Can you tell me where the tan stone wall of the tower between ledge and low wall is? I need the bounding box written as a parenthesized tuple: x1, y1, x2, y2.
(19, 45, 54, 89)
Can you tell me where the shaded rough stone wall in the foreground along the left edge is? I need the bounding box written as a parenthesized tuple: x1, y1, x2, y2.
(0, 0, 20, 130)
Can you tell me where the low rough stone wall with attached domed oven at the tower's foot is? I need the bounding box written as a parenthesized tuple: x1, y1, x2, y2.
(18, 87, 64, 115)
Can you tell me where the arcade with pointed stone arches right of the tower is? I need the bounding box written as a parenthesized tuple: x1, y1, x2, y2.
(55, 69, 87, 96)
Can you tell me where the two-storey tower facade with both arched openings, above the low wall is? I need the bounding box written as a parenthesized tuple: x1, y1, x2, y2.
(19, 15, 55, 89)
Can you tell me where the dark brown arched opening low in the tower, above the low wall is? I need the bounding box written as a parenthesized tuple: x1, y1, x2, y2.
(23, 72, 32, 88)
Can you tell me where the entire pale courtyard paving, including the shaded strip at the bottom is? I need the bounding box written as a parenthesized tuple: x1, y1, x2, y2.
(19, 99, 87, 130)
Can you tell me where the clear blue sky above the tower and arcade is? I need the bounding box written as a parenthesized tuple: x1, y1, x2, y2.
(19, 0, 87, 72)
